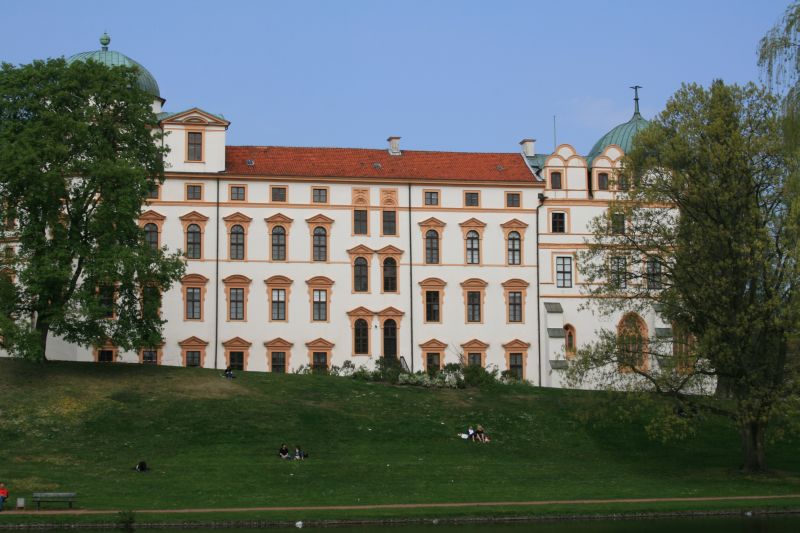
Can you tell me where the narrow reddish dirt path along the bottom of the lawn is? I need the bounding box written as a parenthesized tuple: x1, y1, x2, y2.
(0, 494, 800, 516)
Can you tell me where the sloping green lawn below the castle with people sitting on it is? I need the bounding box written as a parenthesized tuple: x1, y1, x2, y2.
(0, 360, 800, 522)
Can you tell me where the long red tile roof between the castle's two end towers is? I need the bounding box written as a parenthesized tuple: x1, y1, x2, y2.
(225, 146, 537, 183)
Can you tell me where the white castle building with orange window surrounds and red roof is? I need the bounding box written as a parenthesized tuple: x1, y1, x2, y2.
(9, 35, 667, 386)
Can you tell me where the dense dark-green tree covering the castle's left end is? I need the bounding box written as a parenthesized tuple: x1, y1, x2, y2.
(0, 59, 184, 359)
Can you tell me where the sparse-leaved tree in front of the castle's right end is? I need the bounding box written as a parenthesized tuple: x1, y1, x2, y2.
(568, 81, 800, 470)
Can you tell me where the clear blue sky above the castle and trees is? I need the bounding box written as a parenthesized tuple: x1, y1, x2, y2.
(0, 0, 788, 153)
